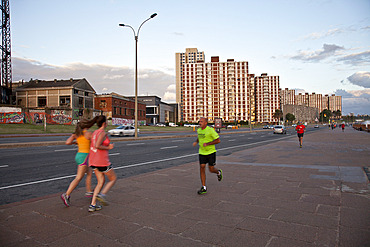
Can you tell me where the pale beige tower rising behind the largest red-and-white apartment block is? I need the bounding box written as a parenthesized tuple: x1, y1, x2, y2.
(176, 48, 205, 121)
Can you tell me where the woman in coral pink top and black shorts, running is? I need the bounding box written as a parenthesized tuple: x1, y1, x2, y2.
(89, 116, 117, 212)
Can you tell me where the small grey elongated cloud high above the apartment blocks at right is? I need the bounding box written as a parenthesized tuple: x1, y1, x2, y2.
(291, 44, 344, 62)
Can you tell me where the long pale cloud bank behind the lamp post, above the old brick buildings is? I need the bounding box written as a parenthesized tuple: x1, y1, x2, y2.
(12, 57, 175, 98)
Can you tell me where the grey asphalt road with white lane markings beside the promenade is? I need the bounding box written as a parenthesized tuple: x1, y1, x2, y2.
(0, 127, 315, 205)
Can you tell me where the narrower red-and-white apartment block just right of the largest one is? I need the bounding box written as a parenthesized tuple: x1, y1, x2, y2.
(254, 73, 280, 123)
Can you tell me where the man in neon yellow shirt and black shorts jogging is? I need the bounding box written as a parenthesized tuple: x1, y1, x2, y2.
(193, 117, 222, 195)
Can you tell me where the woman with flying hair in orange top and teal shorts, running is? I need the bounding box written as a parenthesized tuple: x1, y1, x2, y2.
(61, 119, 96, 207)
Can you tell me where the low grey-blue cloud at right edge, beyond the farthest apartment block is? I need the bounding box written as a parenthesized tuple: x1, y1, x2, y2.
(334, 89, 370, 115)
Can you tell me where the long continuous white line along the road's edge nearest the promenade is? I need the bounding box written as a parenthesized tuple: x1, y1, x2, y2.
(0, 136, 291, 190)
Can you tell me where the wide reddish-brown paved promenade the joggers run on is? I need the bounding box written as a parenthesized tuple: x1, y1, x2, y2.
(0, 128, 370, 247)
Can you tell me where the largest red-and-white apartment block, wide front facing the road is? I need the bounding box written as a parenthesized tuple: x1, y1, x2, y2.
(181, 57, 251, 122)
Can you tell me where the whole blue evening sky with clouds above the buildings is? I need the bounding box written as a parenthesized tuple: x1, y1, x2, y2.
(10, 0, 370, 115)
